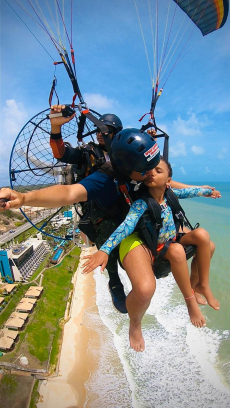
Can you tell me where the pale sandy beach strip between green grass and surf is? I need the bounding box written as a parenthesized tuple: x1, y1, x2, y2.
(37, 247, 96, 408)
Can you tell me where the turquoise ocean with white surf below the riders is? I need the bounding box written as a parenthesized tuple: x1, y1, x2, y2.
(84, 183, 230, 408)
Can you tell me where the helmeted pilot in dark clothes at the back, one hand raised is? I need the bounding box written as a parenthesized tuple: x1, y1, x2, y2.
(50, 105, 127, 313)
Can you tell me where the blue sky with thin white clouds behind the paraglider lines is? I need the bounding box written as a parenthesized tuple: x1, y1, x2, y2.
(0, 0, 230, 186)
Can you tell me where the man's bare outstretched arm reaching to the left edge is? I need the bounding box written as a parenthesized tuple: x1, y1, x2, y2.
(0, 184, 87, 209)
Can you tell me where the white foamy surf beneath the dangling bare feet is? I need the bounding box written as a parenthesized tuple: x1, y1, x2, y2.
(86, 268, 230, 408)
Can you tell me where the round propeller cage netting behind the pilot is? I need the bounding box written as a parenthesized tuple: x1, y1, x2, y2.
(9, 106, 100, 239)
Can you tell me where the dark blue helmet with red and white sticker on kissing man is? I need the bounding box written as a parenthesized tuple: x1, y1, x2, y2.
(111, 128, 160, 176)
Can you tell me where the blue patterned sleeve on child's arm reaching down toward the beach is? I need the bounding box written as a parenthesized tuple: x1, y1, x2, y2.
(100, 199, 148, 255)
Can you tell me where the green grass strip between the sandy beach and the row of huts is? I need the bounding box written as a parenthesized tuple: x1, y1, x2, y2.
(0, 246, 81, 368)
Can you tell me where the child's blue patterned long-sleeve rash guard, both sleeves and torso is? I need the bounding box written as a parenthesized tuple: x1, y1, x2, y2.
(100, 187, 212, 255)
